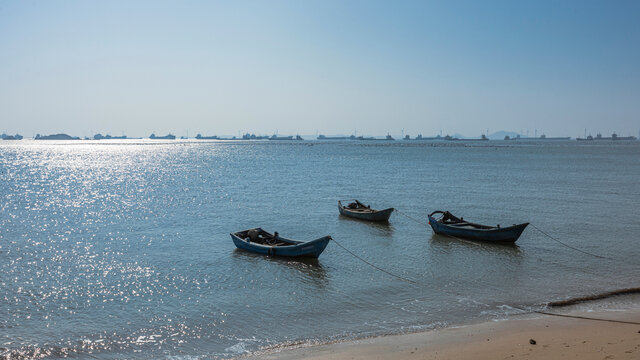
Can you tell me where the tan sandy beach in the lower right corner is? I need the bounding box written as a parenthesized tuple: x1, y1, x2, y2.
(249, 310, 640, 360)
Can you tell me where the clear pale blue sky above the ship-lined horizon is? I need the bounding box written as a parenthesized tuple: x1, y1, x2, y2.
(0, 0, 640, 137)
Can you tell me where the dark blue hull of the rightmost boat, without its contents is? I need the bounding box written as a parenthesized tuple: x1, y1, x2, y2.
(429, 216, 529, 243)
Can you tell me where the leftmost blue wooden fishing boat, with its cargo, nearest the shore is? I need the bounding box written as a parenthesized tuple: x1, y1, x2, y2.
(231, 228, 331, 258)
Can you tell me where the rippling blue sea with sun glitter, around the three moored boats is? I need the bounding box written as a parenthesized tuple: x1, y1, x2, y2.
(0, 140, 640, 359)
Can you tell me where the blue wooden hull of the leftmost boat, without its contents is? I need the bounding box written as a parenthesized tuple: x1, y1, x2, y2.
(230, 229, 331, 258)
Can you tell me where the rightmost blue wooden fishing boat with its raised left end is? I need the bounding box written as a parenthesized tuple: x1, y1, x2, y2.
(429, 211, 529, 243)
